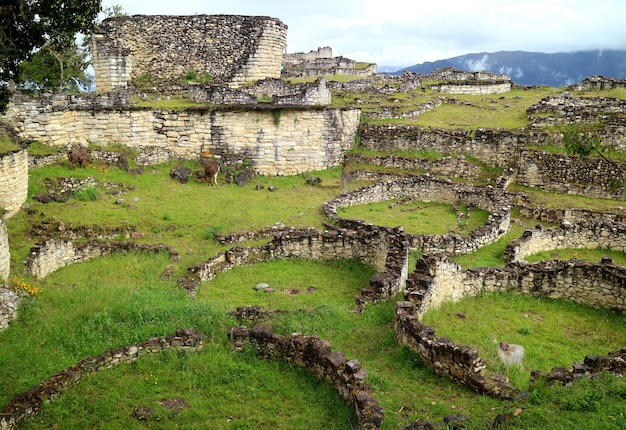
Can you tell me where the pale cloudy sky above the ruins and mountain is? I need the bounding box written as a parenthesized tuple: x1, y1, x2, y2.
(108, 0, 626, 70)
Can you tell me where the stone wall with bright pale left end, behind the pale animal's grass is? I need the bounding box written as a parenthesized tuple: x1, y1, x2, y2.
(404, 254, 626, 317)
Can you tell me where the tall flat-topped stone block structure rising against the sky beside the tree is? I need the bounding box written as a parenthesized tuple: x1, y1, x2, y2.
(92, 15, 287, 91)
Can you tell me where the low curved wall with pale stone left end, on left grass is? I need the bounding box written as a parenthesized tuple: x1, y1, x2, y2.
(24, 239, 178, 279)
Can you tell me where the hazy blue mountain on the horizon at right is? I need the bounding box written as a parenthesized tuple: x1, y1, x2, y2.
(391, 50, 626, 87)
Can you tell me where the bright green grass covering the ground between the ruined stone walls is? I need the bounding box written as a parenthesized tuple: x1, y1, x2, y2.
(0, 81, 626, 429)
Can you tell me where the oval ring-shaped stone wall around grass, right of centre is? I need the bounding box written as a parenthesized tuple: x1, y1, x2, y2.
(323, 175, 511, 255)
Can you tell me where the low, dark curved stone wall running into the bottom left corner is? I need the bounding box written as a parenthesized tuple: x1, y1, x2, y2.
(0, 328, 202, 430)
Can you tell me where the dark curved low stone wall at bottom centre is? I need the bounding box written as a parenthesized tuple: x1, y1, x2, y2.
(229, 325, 384, 429)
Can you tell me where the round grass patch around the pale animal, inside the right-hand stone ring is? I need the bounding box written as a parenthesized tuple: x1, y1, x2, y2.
(416, 293, 626, 390)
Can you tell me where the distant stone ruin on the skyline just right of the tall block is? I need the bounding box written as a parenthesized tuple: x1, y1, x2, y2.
(281, 46, 378, 78)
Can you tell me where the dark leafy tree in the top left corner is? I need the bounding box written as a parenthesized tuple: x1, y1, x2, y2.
(0, 0, 101, 113)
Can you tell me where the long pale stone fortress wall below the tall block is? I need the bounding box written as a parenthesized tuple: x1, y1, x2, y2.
(5, 96, 360, 175)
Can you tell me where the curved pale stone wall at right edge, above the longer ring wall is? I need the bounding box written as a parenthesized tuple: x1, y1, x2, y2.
(504, 220, 626, 263)
